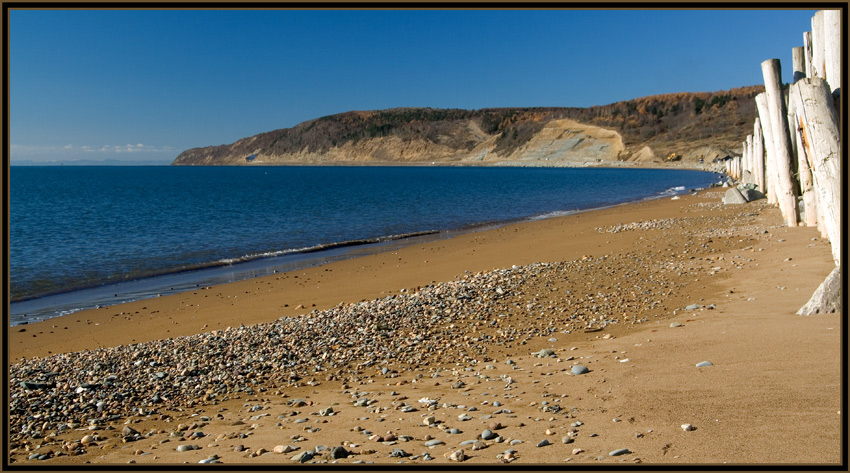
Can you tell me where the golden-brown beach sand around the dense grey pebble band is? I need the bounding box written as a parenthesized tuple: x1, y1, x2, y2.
(8, 189, 844, 467)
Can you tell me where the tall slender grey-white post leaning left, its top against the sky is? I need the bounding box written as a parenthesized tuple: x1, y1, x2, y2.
(761, 59, 799, 227)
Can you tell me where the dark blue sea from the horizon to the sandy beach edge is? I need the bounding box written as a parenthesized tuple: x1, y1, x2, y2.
(7, 166, 721, 326)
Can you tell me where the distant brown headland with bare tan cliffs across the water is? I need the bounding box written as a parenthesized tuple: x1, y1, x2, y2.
(172, 85, 764, 168)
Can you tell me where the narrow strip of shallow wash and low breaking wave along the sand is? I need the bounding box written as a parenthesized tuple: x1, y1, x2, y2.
(9, 179, 716, 327)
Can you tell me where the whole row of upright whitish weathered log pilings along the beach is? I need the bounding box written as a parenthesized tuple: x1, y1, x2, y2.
(726, 10, 843, 314)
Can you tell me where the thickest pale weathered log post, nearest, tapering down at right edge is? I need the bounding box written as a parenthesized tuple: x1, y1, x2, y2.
(791, 78, 842, 264)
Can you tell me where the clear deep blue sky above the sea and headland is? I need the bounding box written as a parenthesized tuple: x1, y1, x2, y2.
(9, 9, 815, 162)
